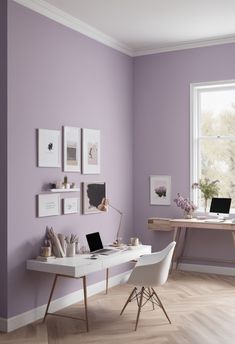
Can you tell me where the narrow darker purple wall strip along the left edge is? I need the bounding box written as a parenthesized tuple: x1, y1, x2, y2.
(0, 0, 7, 318)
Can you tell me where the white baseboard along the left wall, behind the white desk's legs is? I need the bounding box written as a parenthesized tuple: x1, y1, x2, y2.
(0, 271, 130, 332)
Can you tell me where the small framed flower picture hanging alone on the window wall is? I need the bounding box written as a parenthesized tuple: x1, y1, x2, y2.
(150, 176, 171, 205)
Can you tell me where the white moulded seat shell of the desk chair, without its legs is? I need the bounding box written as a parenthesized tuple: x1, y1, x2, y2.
(128, 241, 176, 287)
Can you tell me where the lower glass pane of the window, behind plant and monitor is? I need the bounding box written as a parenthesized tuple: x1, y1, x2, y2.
(199, 138, 235, 208)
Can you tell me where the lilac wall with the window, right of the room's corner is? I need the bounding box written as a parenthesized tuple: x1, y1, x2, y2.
(134, 44, 235, 260)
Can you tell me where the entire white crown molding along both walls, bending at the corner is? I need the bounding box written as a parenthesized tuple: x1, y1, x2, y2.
(13, 0, 235, 57)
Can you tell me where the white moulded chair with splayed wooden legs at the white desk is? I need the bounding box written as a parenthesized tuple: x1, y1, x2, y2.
(120, 241, 176, 331)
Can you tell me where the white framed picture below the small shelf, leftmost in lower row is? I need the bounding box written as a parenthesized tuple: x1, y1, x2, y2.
(38, 194, 60, 217)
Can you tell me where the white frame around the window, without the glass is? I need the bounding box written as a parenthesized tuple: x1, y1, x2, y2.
(190, 80, 235, 214)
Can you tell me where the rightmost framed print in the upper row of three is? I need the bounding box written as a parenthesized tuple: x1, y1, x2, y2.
(82, 129, 100, 174)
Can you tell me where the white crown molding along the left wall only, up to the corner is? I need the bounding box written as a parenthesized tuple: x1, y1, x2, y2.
(14, 0, 133, 56)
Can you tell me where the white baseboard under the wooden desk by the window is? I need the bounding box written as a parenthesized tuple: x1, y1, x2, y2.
(178, 263, 235, 276)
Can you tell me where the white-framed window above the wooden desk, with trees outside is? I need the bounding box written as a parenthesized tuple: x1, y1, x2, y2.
(190, 80, 235, 212)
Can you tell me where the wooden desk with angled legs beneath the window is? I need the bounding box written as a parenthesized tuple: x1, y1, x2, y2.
(148, 217, 235, 269)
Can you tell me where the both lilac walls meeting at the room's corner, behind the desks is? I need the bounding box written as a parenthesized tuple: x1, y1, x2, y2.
(5, 0, 235, 317)
